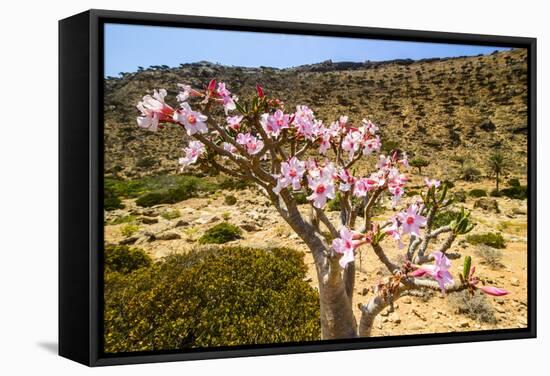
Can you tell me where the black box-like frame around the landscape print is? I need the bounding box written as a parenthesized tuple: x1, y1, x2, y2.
(59, 10, 537, 366)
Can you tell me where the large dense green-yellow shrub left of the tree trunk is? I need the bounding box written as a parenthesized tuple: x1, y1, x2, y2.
(104, 247, 320, 353)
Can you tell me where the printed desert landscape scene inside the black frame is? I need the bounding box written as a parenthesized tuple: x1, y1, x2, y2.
(102, 23, 528, 354)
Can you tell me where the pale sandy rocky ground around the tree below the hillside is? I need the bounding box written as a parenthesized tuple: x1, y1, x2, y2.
(105, 177, 527, 335)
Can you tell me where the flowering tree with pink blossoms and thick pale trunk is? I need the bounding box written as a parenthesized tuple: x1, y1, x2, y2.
(137, 80, 507, 339)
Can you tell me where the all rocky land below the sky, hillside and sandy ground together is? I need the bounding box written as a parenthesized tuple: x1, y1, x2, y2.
(104, 50, 527, 336)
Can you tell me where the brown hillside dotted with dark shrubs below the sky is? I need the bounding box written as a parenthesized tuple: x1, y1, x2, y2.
(104, 50, 527, 179)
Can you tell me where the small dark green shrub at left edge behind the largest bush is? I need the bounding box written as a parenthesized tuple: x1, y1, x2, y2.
(103, 245, 153, 274)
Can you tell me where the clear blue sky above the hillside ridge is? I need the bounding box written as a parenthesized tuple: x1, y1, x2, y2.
(104, 24, 508, 76)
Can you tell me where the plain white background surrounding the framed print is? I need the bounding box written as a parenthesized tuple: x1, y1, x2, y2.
(0, 0, 550, 376)
